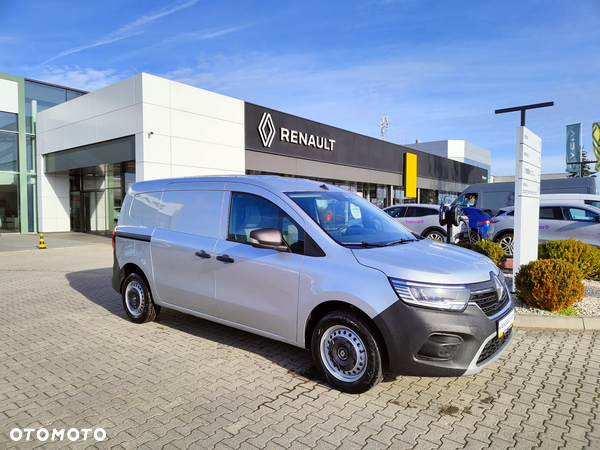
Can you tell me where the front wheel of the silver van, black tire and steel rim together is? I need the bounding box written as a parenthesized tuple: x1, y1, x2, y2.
(311, 311, 383, 394)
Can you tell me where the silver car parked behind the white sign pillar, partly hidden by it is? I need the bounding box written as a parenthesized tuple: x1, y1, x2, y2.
(488, 200, 600, 257)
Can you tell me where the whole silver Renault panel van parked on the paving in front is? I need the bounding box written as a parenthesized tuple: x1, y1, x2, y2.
(112, 176, 515, 393)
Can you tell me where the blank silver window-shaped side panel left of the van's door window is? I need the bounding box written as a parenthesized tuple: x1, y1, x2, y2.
(156, 191, 223, 239)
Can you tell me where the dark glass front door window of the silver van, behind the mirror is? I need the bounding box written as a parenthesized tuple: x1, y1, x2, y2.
(227, 192, 304, 255)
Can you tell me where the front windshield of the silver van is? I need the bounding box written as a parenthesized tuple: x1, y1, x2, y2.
(287, 191, 416, 247)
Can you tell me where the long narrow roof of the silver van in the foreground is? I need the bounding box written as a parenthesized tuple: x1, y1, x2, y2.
(131, 175, 340, 193)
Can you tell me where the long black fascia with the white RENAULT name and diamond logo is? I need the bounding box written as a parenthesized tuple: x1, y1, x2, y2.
(245, 103, 487, 184)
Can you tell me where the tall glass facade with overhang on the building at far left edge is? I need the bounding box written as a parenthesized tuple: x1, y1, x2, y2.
(0, 74, 85, 233)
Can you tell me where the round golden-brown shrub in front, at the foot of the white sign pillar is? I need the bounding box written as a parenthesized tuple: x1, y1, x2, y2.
(515, 259, 583, 311)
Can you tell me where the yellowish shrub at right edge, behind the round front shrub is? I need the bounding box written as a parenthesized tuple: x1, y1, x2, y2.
(538, 238, 600, 280)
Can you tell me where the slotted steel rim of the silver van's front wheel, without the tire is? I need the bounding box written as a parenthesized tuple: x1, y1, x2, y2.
(319, 325, 367, 383)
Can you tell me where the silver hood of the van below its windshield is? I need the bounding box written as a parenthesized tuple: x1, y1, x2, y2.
(352, 239, 499, 284)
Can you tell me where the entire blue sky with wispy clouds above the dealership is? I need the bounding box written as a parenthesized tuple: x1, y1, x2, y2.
(0, 0, 600, 175)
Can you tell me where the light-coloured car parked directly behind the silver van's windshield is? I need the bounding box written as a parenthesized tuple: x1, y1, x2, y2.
(383, 204, 469, 242)
